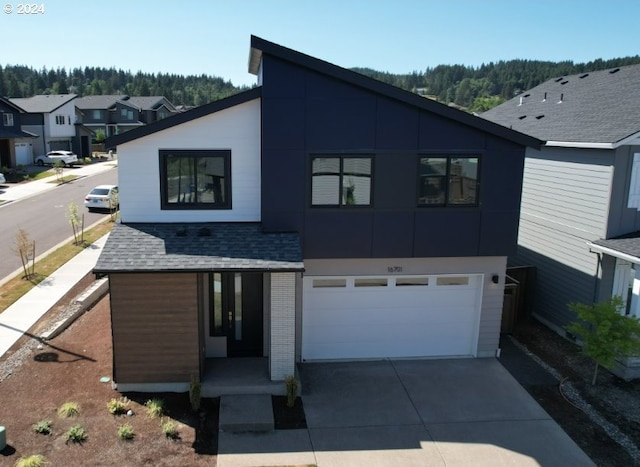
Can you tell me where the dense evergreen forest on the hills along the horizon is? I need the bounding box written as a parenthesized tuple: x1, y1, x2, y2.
(0, 55, 640, 112)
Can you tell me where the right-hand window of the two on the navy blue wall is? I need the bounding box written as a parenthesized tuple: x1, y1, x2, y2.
(418, 155, 479, 206)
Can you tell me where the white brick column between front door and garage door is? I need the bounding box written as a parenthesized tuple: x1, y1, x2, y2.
(269, 272, 296, 381)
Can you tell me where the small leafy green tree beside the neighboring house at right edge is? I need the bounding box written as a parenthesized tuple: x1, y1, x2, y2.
(567, 296, 640, 384)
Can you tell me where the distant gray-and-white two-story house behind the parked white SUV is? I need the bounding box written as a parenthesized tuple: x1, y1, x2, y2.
(11, 94, 76, 159)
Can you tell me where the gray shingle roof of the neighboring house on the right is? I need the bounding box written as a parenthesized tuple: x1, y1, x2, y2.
(481, 65, 640, 144)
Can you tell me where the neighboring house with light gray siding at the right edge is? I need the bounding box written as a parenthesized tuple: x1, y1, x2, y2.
(482, 65, 640, 378)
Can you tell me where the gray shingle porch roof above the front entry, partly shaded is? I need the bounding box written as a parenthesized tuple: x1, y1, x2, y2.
(94, 223, 304, 273)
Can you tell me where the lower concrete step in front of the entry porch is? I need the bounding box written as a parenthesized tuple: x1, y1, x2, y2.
(218, 394, 274, 433)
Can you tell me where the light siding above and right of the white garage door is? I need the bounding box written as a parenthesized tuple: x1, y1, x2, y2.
(304, 256, 507, 357)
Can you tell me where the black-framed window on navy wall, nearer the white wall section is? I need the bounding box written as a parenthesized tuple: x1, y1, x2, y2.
(311, 156, 372, 206)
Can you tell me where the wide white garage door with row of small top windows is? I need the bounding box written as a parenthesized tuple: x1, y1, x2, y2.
(302, 275, 482, 360)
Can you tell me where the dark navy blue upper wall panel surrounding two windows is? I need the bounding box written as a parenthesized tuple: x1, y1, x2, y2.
(262, 54, 525, 258)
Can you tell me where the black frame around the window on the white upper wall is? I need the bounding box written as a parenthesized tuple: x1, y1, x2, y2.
(158, 149, 232, 211)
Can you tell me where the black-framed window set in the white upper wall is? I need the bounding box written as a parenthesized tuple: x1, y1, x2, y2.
(160, 150, 231, 209)
